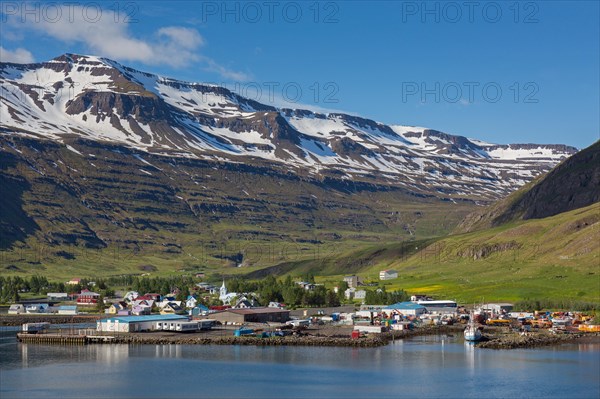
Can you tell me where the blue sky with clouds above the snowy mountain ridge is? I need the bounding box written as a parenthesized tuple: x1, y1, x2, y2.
(0, 1, 600, 148)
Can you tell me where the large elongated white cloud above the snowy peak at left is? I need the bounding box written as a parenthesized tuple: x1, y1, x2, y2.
(7, 6, 247, 80)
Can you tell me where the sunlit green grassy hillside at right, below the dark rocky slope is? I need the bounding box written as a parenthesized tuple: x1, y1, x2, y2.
(328, 204, 600, 303)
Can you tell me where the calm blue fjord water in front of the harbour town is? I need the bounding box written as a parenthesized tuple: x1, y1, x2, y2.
(0, 336, 600, 399)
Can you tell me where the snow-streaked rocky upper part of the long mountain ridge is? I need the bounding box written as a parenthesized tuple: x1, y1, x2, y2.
(0, 54, 577, 199)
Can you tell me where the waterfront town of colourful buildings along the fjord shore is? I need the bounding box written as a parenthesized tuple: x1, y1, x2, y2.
(3, 270, 600, 346)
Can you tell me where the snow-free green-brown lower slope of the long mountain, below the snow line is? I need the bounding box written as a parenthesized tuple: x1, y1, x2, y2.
(0, 137, 475, 279)
